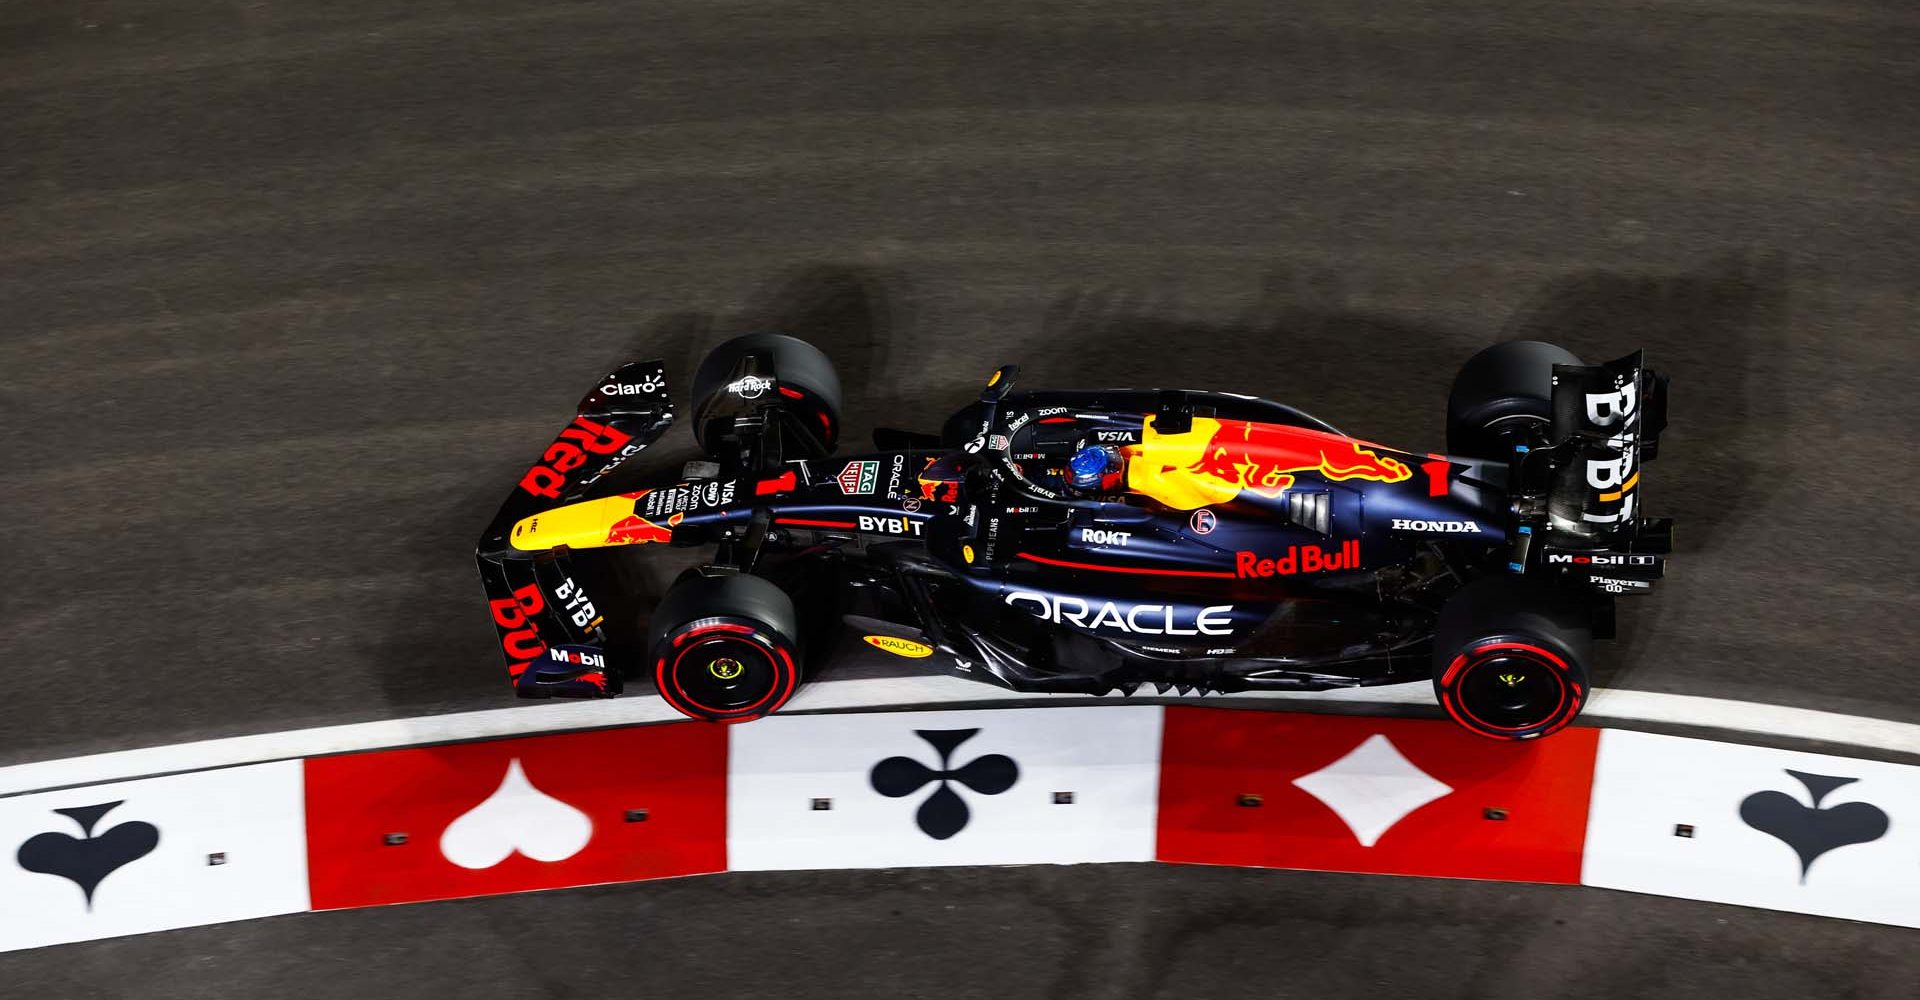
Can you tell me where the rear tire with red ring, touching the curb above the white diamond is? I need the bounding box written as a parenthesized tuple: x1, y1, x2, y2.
(1434, 578, 1594, 741)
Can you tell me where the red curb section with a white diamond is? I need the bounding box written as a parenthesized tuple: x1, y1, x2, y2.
(1158, 706, 1599, 883)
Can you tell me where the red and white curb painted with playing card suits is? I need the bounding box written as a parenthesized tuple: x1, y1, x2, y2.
(0, 704, 1920, 948)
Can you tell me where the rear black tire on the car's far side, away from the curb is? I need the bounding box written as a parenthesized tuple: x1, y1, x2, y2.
(1446, 340, 1580, 461)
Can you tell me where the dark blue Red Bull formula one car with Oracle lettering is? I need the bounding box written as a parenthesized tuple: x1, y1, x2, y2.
(478, 334, 1672, 739)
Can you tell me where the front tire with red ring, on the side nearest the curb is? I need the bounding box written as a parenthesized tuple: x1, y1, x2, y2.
(647, 574, 803, 722)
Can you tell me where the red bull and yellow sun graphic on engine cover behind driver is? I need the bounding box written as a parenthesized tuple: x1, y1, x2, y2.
(1127, 417, 1413, 511)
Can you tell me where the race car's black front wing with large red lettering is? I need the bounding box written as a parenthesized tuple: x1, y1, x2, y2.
(476, 361, 674, 699)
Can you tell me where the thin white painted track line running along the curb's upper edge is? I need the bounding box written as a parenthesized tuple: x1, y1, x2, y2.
(0, 676, 1920, 795)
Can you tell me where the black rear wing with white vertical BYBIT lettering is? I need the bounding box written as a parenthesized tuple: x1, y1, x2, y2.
(1513, 351, 1672, 593)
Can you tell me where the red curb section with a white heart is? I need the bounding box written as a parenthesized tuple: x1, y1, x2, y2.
(305, 722, 728, 910)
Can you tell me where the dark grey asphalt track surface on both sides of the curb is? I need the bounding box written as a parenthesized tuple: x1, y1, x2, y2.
(0, 0, 1920, 996)
